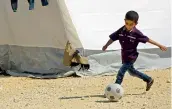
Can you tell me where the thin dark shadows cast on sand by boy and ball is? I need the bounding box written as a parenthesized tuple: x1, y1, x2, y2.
(59, 92, 146, 103)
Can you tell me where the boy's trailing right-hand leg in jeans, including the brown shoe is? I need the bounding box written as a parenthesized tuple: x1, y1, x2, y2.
(128, 65, 154, 91)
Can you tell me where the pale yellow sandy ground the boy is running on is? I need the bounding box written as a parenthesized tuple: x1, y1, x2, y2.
(0, 68, 171, 109)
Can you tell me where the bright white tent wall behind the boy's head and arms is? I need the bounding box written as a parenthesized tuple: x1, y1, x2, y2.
(66, 0, 172, 50)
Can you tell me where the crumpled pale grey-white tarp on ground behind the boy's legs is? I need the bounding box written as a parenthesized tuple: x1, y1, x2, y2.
(75, 51, 171, 77)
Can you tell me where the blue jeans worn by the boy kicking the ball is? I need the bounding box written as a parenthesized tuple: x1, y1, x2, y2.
(115, 62, 152, 84)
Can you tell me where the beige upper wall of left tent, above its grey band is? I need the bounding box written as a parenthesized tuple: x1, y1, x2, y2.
(0, 0, 83, 49)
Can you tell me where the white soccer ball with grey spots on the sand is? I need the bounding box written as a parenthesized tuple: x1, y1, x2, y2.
(105, 84, 124, 102)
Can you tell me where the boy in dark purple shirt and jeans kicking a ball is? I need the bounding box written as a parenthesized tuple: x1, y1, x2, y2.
(102, 11, 167, 91)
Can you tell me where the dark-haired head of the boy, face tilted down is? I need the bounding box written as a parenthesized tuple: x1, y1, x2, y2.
(125, 11, 139, 31)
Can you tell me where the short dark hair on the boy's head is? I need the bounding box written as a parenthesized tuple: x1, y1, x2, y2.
(125, 11, 139, 23)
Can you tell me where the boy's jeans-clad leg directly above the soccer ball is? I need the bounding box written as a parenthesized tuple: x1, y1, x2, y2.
(115, 63, 132, 84)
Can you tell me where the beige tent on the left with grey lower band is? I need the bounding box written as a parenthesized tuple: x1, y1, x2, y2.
(0, 0, 83, 78)
